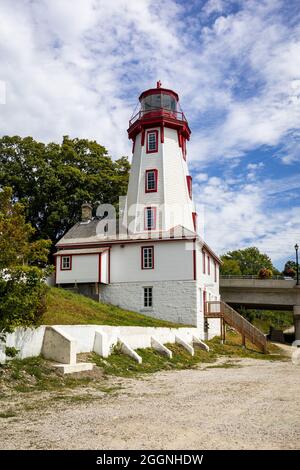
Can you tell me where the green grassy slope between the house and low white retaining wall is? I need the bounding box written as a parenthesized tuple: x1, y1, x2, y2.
(39, 287, 187, 328)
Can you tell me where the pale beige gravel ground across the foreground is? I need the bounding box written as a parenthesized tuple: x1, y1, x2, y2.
(0, 359, 300, 449)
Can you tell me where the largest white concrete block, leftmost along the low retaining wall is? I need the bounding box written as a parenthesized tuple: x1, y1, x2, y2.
(42, 326, 77, 364)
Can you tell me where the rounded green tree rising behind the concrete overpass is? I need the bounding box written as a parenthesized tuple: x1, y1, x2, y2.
(222, 247, 278, 275)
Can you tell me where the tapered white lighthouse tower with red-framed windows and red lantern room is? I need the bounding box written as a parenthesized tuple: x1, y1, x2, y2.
(127, 82, 196, 233)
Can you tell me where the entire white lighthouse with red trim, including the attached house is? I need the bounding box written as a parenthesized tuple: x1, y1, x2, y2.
(56, 82, 220, 338)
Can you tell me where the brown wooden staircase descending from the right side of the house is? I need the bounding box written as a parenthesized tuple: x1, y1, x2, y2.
(204, 301, 267, 353)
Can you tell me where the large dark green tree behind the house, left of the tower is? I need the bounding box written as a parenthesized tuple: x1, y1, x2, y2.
(0, 136, 130, 253)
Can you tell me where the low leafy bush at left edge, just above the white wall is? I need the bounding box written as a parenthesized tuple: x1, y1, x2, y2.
(0, 266, 48, 336)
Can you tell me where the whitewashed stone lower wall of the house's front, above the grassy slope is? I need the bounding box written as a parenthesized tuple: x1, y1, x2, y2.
(100, 281, 199, 326)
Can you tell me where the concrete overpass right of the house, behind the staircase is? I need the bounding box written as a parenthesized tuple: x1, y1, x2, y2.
(220, 276, 300, 340)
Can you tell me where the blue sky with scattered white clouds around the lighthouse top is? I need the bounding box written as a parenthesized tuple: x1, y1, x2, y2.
(0, 0, 300, 267)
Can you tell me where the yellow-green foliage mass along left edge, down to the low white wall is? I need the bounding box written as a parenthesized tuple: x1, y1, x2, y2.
(0, 187, 51, 338)
